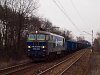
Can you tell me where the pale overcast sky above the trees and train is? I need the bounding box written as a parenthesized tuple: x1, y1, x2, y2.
(38, 0, 100, 40)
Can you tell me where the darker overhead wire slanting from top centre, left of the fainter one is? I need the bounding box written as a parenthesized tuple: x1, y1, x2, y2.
(53, 0, 81, 32)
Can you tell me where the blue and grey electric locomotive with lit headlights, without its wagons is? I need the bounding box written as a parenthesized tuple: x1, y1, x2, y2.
(27, 31, 65, 60)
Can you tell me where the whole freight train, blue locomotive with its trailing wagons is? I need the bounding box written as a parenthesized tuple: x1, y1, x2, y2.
(26, 31, 91, 60)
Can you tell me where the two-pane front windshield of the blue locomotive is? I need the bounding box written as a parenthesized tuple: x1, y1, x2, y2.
(28, 34, 46, 40)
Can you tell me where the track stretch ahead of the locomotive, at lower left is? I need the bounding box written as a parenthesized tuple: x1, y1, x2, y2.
(0, 61, 32, 75)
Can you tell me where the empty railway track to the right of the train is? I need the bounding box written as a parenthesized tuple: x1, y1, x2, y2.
(37, 51, 86, 75)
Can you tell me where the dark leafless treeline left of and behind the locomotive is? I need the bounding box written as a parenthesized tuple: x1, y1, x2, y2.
(0, 0, 71, 60)
